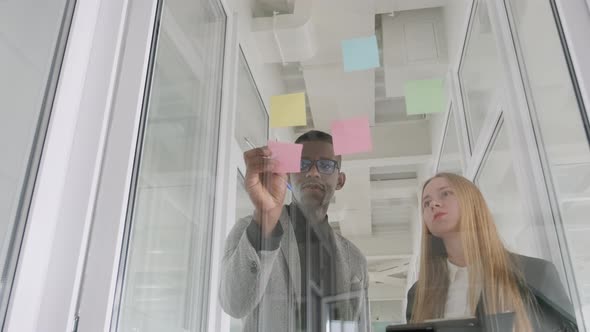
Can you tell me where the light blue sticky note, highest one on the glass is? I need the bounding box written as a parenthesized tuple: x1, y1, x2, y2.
(342, 35, 379, 72)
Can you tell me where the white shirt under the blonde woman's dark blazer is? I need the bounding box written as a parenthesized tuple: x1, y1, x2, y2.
(444, 259, 473, 318)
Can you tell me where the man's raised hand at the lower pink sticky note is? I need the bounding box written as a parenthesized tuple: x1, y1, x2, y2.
(244, 146, 287, 237)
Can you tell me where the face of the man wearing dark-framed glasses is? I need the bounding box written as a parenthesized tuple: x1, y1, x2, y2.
(290, 141, 346, 209)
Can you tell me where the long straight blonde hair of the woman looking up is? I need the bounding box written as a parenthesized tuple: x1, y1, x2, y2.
(411, 173, 533, 331)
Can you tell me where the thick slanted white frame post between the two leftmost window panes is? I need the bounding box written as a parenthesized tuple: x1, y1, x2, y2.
(77, 0, 158, 331)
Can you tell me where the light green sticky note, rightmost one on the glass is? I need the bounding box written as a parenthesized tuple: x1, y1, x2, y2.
(404, 79, 446, 115)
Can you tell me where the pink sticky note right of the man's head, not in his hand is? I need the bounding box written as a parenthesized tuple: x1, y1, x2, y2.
(332, 117, 373, 155)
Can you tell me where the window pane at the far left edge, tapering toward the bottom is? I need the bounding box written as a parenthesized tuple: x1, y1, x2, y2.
(0, 0, 72, 322)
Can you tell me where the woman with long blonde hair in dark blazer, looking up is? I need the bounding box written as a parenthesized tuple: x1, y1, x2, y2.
(406, 173, 577, 331)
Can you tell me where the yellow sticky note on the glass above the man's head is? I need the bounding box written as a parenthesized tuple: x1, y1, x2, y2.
(270, 92, 307, 128)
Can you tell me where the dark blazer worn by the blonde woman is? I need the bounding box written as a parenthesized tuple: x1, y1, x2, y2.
(406, 254, 578, 331)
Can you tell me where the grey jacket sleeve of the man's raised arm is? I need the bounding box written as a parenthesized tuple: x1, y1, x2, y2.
(219, 217, 280, 318)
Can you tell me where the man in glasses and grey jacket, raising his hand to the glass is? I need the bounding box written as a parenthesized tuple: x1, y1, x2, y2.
(219, 131, 370, 332)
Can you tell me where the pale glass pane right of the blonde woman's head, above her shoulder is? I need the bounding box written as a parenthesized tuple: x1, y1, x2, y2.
(476, 125, 542, 257)
